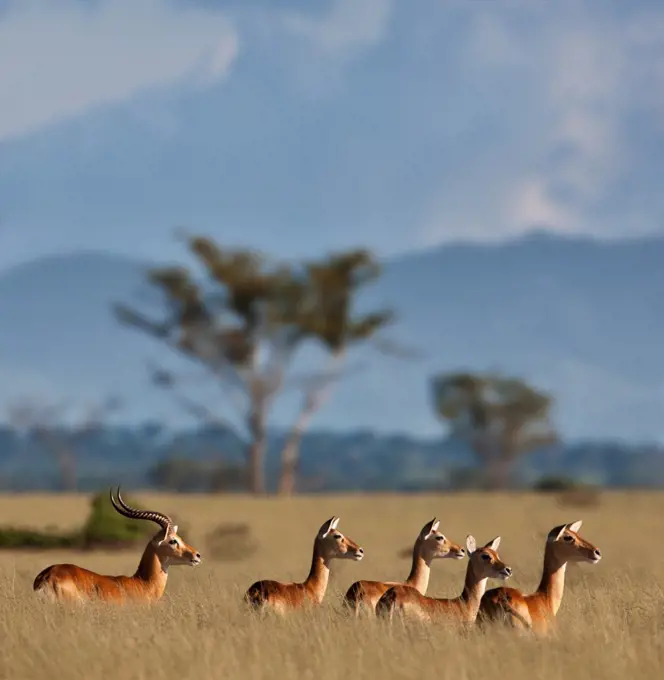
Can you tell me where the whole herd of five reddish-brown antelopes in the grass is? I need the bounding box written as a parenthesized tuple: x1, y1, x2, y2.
(33, 488, 601, 635)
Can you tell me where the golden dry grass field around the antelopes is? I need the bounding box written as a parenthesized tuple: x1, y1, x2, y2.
(0, 493, 664, 680)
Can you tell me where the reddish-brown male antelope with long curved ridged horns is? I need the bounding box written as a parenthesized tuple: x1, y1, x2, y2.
(32, 487, 201, 603)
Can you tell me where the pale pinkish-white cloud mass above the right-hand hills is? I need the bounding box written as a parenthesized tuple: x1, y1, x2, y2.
(422, 0, 664, 243)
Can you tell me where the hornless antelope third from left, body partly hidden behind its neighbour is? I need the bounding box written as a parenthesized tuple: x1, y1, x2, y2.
(343, 517, 466, 615)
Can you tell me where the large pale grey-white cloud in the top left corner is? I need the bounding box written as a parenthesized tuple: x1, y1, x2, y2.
(0, 0, 238, 141)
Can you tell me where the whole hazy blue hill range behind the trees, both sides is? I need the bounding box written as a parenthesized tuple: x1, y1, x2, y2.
(0, 233, 664, 439)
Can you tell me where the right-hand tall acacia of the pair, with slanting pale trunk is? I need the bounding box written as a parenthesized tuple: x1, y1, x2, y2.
(279, 249, 393, 495)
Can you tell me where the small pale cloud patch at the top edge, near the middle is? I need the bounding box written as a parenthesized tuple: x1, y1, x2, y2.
(282, 0, 392, 57)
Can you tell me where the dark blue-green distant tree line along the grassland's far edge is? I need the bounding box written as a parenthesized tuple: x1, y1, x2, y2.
(0, 412, 664, 493)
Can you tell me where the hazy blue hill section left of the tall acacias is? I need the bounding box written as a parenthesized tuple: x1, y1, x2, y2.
(0, 253, 175, 418)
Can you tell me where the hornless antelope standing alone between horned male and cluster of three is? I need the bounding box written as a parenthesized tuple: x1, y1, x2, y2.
(244, 517, 364, 614)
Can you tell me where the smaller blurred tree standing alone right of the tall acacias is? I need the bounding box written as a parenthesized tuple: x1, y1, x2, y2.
(431, 373, 557, 489)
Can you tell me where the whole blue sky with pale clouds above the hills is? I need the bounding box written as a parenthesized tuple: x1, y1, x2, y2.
(0, 0, 664, 269)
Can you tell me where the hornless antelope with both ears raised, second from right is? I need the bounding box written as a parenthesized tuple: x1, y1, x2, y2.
(376, 536, 512, 623)
